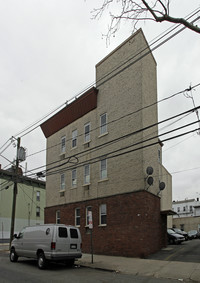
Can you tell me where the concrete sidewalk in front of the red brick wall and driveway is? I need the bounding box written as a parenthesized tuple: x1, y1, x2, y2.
(0, 244, 200, 282)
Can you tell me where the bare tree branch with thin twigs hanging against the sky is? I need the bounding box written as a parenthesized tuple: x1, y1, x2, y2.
(92, 0, 200, 38)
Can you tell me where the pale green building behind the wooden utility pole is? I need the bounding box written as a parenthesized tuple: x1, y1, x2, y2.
(0, 166, 46, 239)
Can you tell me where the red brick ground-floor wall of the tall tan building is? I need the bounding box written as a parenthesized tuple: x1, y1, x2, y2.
(45, 191, 166, 257)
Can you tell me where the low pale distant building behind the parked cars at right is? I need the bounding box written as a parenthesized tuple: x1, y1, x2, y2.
(172, 198, 200, 231)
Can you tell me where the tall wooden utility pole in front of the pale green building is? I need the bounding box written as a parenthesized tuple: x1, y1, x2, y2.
(10, 138, 20, 246)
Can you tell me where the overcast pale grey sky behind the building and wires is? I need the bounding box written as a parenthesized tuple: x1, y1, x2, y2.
(0, 0, 200, 200)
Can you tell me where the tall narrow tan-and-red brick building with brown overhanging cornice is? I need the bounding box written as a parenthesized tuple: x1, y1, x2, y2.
(41, 30, 172, 257)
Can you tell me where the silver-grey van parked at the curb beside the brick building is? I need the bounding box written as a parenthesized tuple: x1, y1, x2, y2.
(10, 224, 82, 269)
